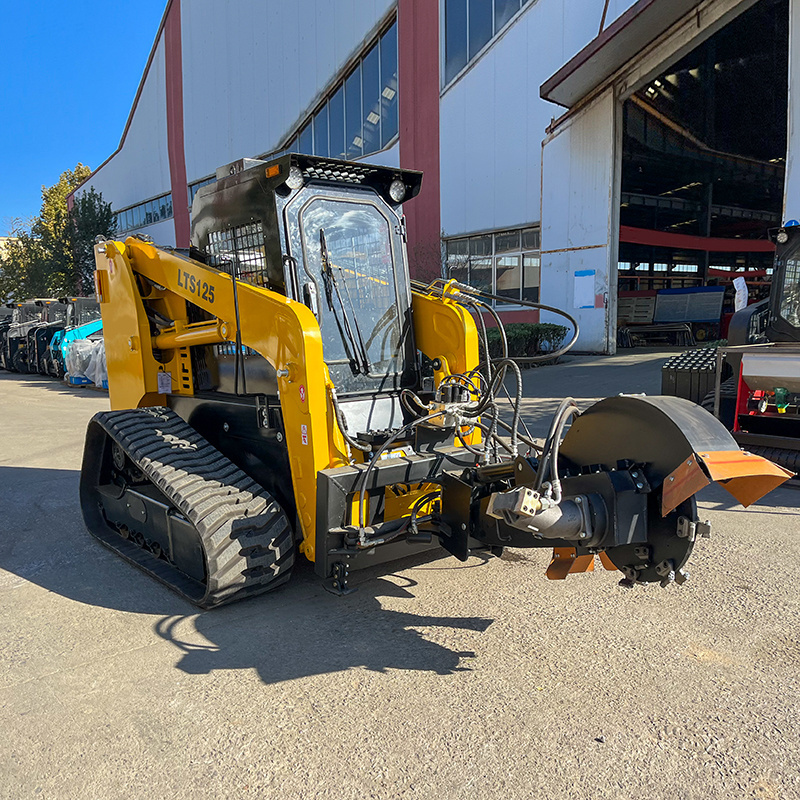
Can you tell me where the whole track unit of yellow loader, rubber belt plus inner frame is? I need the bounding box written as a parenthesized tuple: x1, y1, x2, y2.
(81, 408, 294, 608)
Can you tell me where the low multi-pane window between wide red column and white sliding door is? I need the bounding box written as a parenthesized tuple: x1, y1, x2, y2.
(445, 228, 541, 305)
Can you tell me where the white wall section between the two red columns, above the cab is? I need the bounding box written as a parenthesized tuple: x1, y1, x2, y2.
(181, 0, 396, 183)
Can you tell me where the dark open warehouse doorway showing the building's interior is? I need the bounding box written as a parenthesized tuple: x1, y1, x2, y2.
(617, 0, 789, 347)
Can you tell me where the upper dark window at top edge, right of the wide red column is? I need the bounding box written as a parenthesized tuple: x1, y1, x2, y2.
(444, 0, 530, 85)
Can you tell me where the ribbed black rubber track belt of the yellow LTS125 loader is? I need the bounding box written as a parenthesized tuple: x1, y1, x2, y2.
(84, 408, 294, 608)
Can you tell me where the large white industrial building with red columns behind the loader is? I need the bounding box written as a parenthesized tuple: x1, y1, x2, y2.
(70, 0, 800, 352)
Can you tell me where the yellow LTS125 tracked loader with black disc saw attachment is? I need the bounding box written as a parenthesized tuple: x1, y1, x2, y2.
(81, 155, 787, 607)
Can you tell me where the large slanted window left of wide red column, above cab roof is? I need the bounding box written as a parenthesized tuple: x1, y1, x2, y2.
(262, 20, 398, 159)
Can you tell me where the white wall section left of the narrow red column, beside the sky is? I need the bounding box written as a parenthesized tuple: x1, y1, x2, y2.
(79, 37, 175, 238)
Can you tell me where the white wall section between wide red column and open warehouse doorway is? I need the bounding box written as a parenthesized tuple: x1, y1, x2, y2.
(440, 0, 634, 236)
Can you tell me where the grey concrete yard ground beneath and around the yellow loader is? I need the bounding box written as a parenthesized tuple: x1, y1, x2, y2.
(0, 360, 800, 800)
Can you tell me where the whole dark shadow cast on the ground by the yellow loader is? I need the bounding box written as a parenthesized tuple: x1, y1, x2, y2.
(0, 466, 493, 683)
